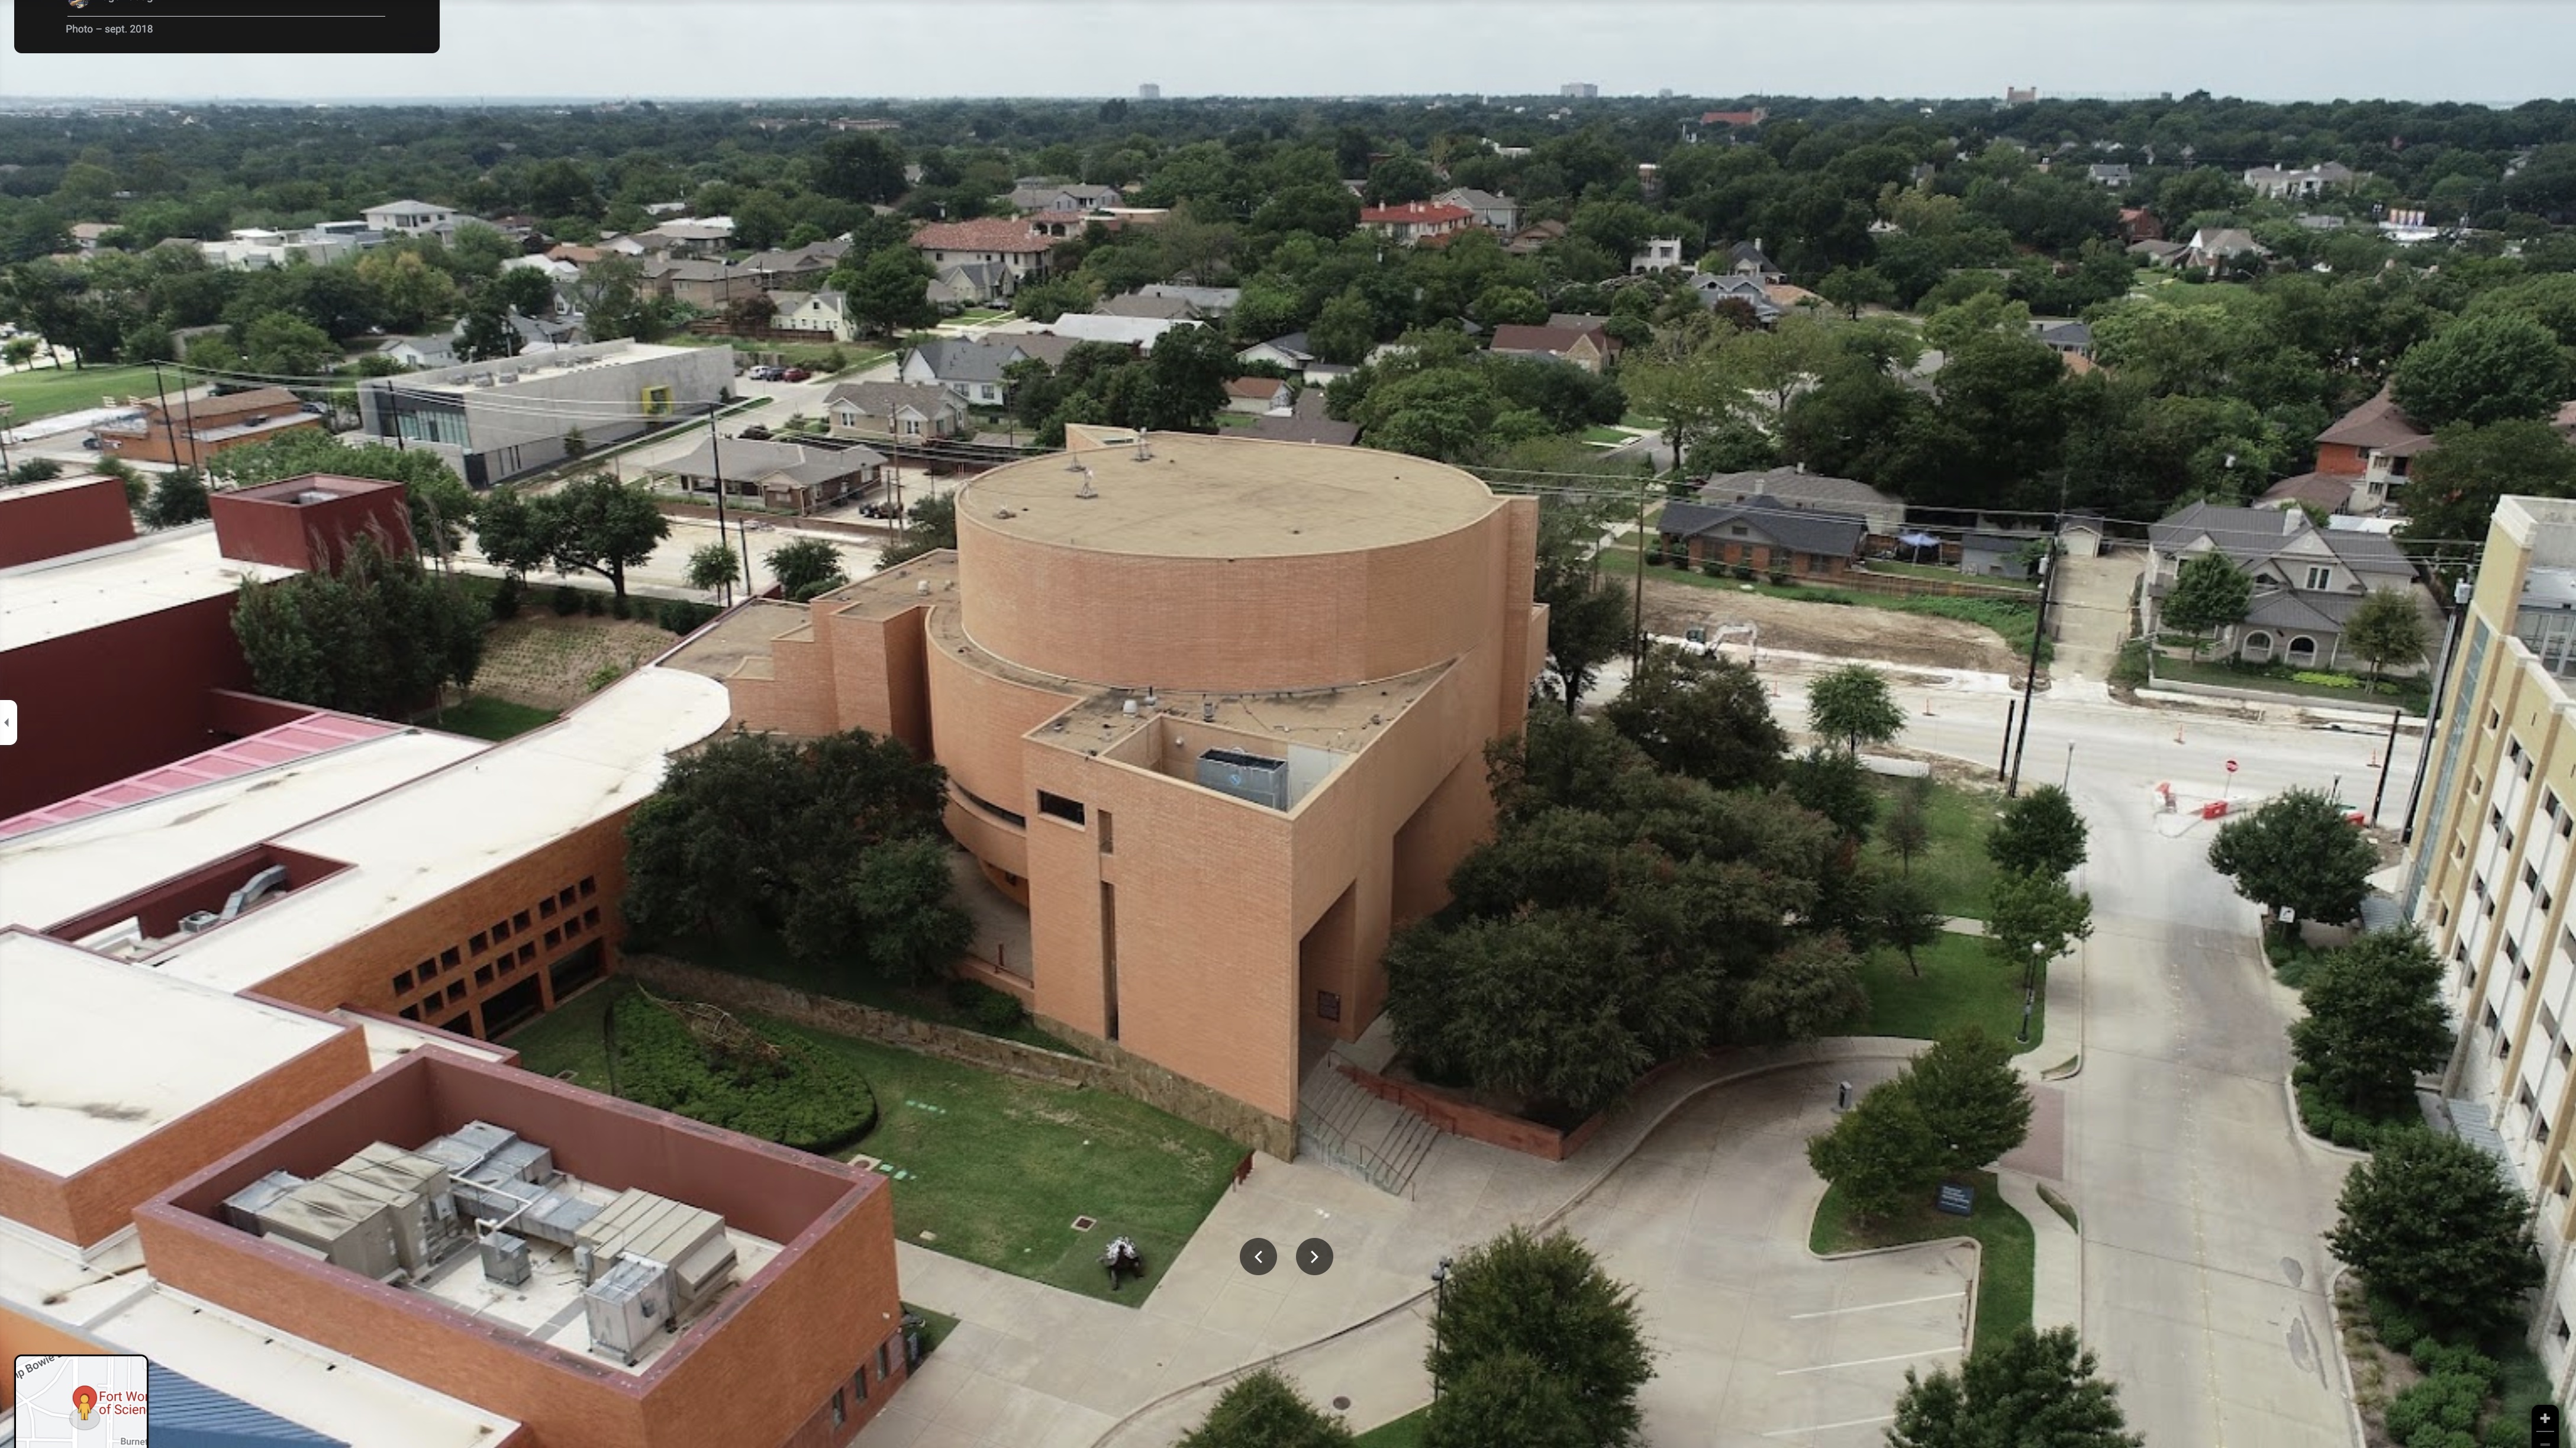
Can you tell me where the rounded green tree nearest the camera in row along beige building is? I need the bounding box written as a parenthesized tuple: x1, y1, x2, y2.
(2326, 1131, 2542, 1337)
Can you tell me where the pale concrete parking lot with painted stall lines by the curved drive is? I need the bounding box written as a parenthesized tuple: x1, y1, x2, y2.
(1566, 1067, 1976, 1448)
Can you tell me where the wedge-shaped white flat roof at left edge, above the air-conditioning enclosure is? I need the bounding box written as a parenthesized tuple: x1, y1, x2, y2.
(0, 933, 340, 1178)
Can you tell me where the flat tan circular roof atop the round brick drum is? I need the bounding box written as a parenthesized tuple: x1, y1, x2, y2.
(958, 433, 1497, 559)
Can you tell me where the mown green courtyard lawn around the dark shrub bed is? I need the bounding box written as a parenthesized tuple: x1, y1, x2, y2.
(505, 979, 1242, 1307)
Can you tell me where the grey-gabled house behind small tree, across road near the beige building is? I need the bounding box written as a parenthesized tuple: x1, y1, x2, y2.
(2146, 502, 2432, 672)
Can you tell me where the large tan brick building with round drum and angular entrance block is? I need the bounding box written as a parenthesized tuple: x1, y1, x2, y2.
(675, 428, 1548, 1154)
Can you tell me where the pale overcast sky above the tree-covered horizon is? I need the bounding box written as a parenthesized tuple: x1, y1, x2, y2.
(15, 0, 2576, 106)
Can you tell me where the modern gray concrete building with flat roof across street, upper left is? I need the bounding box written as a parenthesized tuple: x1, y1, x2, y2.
(358, 340, 734, 487)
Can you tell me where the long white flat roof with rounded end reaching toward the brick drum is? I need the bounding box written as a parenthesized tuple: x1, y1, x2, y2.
(152, 667, 731, 992)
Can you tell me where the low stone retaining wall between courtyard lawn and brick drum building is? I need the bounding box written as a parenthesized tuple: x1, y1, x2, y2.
(602, 956, 1296, 1162)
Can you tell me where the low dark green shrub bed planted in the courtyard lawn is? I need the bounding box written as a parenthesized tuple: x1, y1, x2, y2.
(613, 997, 876, 1154)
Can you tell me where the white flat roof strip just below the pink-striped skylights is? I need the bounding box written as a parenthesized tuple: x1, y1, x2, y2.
(0, 732, 492, 930)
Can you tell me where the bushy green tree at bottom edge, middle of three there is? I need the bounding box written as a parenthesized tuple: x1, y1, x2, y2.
(1424, 1227, 1654, 1448)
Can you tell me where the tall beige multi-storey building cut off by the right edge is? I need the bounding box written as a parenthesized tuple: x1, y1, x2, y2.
(2406, 497, 2576, 1402)
